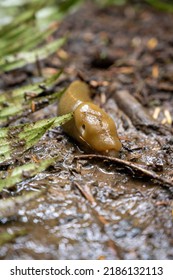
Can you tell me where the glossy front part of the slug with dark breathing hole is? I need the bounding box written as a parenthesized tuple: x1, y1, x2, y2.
(74, 102, 122, 152)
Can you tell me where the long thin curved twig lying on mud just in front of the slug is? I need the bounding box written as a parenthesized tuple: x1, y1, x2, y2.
(74, 154, 173, 187)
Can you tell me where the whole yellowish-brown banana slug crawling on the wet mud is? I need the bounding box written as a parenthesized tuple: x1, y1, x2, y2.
(58, 80, 122, 153)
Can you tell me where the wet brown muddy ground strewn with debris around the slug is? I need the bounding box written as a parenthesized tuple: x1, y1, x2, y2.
(0, 1, 173, 260)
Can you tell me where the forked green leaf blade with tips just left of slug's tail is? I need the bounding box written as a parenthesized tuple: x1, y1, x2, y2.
(0, 71, 63, 126)
